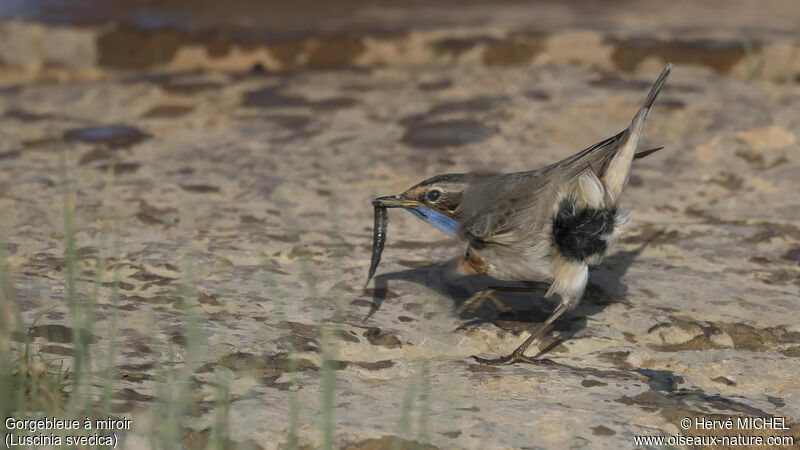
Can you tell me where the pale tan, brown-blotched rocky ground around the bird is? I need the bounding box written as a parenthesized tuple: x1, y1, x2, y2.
(0, 1, 800, 448)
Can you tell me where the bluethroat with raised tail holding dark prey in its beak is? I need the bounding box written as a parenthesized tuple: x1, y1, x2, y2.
(367, 64, 672, 364)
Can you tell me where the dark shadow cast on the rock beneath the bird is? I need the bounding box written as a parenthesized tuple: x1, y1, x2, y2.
(365, 239, 652, 354)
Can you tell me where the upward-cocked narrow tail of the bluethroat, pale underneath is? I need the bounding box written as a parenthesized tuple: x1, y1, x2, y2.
(602, 64, 672, 202)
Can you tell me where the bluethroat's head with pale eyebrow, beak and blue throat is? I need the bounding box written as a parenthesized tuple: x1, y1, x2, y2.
(372, 174, 469, 236)
